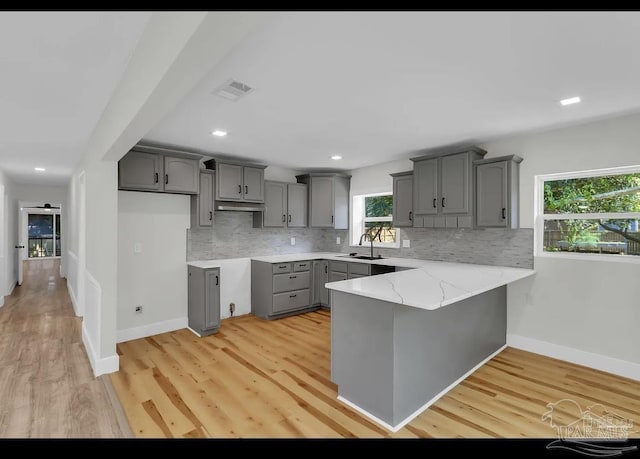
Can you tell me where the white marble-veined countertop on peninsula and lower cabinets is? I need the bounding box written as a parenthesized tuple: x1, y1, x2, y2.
(188, 252, 535, 309)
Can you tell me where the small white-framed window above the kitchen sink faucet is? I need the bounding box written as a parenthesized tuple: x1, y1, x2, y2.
(351, 193, 400, 248)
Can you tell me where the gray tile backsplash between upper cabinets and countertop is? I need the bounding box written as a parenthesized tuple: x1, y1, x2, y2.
(187, 211, 533, 268)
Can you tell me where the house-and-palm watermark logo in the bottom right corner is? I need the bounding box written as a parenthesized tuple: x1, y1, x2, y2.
(542, 398, 638, 457)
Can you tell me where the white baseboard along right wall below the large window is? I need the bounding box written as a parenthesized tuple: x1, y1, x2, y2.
(507, 334, 640, 381)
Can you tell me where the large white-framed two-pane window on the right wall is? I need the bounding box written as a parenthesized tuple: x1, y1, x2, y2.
(536, 166, 640, 261)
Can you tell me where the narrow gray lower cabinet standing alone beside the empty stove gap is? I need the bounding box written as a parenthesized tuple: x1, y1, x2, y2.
(188, 266, 220, 336)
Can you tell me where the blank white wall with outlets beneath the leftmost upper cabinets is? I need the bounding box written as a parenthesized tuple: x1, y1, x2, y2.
(117, 191, 190, 342)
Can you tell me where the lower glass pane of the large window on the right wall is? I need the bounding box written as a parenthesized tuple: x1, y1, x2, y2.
(543, 219, 640, 256)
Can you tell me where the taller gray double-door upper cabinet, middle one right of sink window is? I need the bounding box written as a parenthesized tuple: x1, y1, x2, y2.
(411, 147, 486, 228)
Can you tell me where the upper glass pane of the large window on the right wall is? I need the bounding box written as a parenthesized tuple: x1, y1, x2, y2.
(544, 173, 640, 214)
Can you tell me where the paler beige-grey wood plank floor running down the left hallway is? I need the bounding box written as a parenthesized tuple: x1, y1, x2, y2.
(0, 259, 130, 438)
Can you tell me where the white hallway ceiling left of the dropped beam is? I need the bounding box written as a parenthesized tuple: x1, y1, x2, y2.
(0, 12, 151, 185)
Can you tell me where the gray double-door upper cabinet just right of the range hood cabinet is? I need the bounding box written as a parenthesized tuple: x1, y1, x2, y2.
(253, 180, 307, 228)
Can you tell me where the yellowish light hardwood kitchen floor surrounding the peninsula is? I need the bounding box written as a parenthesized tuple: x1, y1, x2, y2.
(111, 311, 640, 438)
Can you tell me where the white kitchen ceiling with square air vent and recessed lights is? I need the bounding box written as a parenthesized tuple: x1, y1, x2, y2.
(144, 12, 640, 169)
